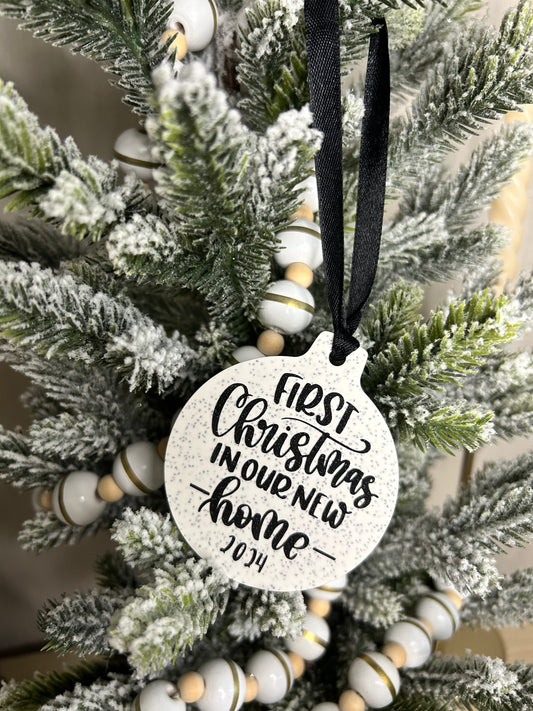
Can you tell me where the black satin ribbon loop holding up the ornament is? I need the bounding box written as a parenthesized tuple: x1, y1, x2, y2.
(305, 0, 390, 363)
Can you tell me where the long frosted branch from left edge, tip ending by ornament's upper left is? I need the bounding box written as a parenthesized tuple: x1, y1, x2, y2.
(0, 263, 193, 391)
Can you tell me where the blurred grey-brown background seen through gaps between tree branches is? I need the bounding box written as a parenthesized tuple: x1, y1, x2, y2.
(0, 0, 533, 675)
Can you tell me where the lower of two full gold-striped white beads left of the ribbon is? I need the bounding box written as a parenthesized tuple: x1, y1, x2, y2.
(259, 279, 315, 335)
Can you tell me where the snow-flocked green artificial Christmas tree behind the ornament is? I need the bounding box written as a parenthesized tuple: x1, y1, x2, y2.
(0, 0, 533, 711)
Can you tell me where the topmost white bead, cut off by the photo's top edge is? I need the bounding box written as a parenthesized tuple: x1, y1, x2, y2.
(168, 0, 218, 52)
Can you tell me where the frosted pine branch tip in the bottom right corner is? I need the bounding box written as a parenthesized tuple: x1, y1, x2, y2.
(399, 656, 533, 711)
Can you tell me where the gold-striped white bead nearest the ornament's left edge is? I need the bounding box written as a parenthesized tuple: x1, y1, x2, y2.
(113, 442, 164, 496)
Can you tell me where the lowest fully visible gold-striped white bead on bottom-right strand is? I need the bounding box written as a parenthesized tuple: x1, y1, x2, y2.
(348, 652, 400, 709)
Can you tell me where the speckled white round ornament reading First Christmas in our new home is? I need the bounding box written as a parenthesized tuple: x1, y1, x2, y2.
(165, 333, 398, 591)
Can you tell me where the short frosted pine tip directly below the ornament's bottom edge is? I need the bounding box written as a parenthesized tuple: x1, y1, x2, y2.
(224, 587, 306, 640)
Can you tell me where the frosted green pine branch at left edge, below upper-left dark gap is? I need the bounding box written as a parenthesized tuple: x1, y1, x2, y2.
(0, 81, 148, 231)
